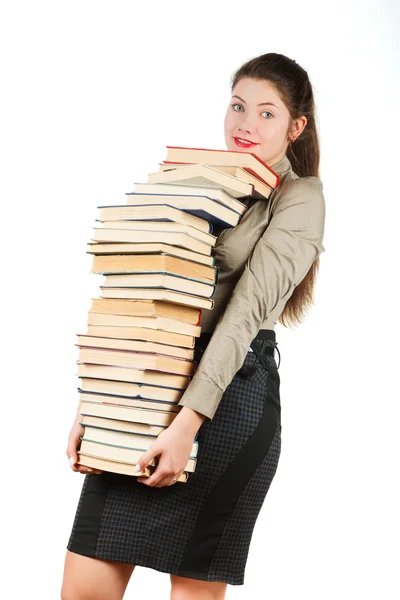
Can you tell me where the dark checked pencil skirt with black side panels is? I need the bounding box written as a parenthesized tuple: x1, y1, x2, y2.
(67, 330, 281, 585)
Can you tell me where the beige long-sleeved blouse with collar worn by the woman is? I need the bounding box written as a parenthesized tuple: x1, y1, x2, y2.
(179, 156, 325, 419)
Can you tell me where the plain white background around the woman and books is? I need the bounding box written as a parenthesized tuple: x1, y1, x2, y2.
(0, 0, 400, 600)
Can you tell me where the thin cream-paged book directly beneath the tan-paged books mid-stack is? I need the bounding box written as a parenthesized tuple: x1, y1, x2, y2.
(76, 333, 194, 360)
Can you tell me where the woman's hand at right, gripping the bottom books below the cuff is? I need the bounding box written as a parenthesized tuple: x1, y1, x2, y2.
(137, 407, 205, 487)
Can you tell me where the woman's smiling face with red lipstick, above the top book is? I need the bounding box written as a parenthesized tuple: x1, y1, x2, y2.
(224, 77, 292, 166)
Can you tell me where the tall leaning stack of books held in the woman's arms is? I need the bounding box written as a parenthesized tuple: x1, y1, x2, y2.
(77, 146, 279, 482)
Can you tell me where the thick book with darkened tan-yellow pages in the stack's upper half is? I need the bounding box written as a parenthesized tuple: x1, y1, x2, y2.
(92, 252, 218, 284)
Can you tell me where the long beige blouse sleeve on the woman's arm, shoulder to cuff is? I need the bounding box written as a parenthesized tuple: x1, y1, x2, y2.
(178, 177, 325, 419)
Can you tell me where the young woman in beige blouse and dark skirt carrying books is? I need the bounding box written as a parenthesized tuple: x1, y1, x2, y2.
(62, 53, 325, 600)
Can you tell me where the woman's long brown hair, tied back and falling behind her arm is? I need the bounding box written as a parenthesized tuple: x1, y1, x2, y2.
(231, 52, 320, 327)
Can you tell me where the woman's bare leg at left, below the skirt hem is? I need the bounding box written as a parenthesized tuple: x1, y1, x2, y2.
(61, 550, 135, 600)
